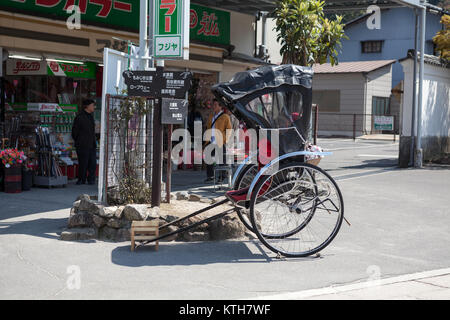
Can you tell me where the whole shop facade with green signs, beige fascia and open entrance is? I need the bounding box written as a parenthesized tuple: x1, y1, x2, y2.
(0, 0, 266, 191)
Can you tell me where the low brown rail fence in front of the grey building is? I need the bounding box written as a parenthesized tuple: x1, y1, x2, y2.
(312, 107, 400, 140)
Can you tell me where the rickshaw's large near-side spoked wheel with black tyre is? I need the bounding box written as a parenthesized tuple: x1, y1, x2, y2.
(250, 163, 344, 257)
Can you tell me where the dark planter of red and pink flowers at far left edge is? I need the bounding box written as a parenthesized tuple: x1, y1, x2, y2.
(0, 149, 26, 193)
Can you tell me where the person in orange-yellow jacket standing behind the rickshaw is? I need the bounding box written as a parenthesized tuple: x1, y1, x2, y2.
(205, 99, 232, 182)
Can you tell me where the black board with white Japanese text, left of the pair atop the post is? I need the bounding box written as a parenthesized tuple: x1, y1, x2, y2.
(122, 70, 161, 97)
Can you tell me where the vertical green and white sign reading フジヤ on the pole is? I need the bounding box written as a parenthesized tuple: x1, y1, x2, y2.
(153, 0, 189, 59)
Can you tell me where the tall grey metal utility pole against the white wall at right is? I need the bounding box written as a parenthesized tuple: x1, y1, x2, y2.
(414, 7, 427, 168)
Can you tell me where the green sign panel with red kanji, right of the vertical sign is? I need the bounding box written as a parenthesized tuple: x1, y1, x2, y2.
(189, 4, 230, 45)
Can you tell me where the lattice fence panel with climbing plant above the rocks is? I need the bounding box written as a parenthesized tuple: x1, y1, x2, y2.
(104, 95, 153, 205)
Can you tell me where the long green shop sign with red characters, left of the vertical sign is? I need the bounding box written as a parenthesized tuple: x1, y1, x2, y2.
(0, 0, 140, 31)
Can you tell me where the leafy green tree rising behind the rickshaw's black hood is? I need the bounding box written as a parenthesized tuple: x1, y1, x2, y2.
(274, 0, 348, 66)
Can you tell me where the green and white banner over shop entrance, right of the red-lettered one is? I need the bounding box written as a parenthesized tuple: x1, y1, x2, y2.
(47, 61, 97, 79)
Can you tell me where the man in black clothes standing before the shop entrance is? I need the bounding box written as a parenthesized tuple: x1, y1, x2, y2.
(72, 99, 97, 184)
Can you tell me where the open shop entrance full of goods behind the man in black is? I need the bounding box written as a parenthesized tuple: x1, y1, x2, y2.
(2, 53, 101, 182)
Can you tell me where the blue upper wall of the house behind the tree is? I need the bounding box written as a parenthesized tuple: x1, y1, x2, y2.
(338, 7, 442, 87)
